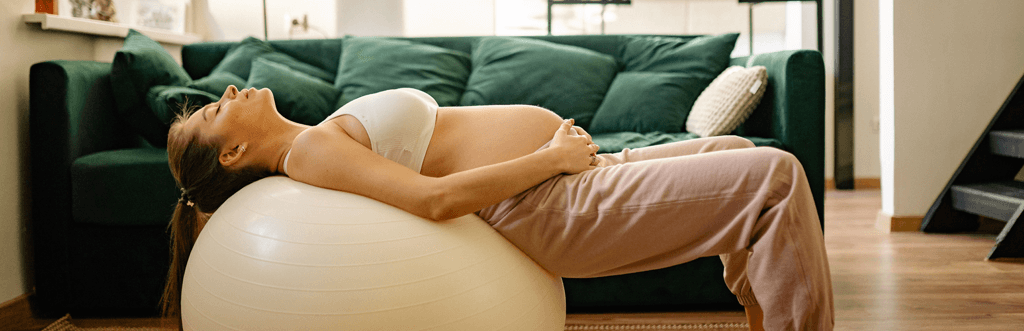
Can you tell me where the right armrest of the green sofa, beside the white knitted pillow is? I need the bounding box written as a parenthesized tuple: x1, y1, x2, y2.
(731, 49, 825, 224)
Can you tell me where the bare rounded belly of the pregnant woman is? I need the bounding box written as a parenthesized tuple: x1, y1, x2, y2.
(421, 106, 562, 177)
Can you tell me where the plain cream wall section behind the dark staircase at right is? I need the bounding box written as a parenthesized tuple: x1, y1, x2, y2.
(879, 0, 1024, 216)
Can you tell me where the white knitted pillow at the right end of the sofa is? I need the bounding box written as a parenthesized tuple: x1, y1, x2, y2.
(686, 66, 768, 137)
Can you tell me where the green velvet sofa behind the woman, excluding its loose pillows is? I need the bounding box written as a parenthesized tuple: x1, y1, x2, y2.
(30, 36, 824, 317)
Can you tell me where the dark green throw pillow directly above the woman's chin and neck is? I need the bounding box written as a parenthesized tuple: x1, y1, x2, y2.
(245, 58, 338, 125)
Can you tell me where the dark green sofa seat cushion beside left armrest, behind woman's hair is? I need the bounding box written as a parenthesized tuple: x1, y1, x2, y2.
(71, 148, 180, 225)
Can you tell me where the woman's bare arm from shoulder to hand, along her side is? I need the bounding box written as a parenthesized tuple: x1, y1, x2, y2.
(289, 120, 597, 219)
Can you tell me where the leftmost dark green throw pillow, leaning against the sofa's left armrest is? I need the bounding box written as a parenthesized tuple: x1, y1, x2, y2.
(111, 30, 191, 148)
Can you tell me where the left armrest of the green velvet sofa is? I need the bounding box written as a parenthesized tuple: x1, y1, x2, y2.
(29, 60, 141, 311)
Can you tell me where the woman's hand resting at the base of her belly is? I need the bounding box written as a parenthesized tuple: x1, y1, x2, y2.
(548, 119, 598, 174)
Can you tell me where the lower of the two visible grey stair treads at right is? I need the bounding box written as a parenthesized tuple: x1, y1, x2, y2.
(950, 180, 1024, 221)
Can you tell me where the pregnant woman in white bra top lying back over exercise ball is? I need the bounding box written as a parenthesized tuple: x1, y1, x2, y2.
(163, 86, 834, 330)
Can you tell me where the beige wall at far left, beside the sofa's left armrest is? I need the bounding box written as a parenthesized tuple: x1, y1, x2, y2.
(0, 1, 93, 303)
